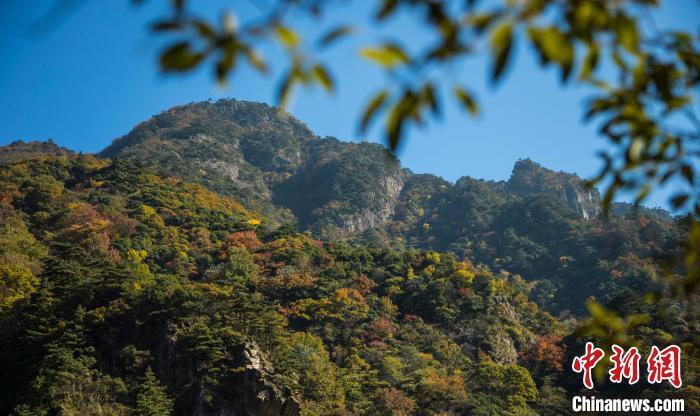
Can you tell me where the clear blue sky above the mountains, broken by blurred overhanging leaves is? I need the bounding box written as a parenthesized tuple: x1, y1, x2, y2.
(0, 0, 700, 206)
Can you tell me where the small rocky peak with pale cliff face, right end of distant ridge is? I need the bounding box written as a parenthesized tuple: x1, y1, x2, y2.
(506, 159, 600, 220)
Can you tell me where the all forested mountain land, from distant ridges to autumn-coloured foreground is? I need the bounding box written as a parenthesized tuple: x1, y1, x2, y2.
(0, 100, 700, 416)
